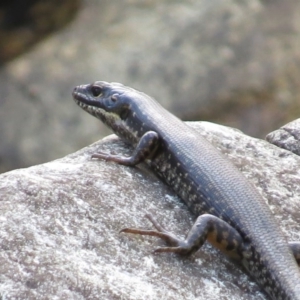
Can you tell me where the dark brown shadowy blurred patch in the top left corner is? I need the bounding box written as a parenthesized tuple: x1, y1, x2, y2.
(0, 0, 80, 65)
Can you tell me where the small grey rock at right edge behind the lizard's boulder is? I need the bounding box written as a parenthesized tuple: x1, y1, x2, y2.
(266, 119, 300, 155)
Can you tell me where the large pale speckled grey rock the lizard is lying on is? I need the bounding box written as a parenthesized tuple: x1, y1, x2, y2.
(0, 122, 300, 300)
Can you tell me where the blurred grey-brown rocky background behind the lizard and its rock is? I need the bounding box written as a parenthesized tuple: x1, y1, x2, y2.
(0, 0, 300, 172)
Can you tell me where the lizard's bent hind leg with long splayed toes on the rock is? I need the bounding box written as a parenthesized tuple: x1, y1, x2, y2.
(121, 214, 243, 259)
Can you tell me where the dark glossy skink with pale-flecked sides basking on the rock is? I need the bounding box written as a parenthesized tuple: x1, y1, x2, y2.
(73, 81, 300, 300)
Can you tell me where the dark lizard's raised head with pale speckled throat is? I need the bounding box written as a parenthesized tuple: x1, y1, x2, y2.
(73, 81, 149, 142)
